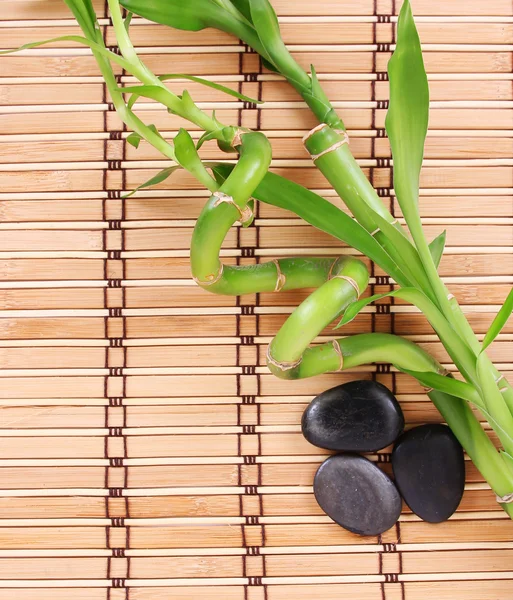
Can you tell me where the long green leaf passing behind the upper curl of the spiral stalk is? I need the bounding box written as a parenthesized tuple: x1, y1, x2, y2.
(214, 164, 406, 285)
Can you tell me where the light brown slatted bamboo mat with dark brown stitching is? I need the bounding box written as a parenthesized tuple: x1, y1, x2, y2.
(0, 0, 513, 600)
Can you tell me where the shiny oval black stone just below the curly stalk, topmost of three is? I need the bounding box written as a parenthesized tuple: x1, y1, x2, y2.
(301, 380, 404, 452)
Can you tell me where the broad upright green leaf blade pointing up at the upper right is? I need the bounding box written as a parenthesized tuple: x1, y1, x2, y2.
(385, 0, 429, 221)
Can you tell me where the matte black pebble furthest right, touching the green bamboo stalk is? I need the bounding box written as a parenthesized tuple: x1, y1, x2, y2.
(392, 425, 465, 523)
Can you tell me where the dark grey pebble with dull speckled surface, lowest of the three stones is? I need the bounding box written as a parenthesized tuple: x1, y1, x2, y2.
(314, 454, 402, 535)
